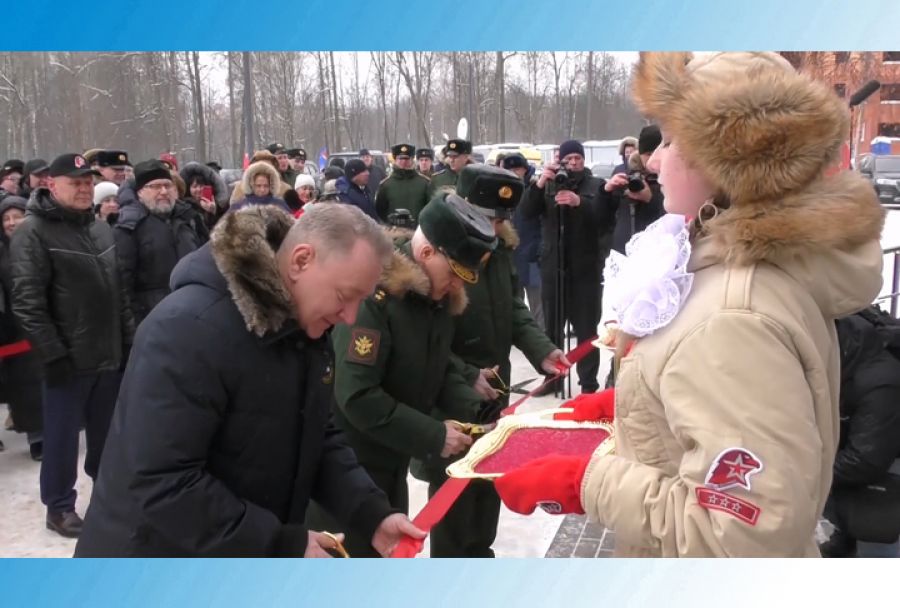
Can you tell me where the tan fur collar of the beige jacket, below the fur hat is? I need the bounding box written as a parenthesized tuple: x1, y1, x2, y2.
(703, 171, 885, 264)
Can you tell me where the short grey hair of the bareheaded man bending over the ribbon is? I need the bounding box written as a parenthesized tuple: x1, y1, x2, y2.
(281, 203, 394, 266)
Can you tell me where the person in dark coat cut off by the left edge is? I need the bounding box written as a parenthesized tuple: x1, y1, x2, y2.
(0, 196, 44, 460)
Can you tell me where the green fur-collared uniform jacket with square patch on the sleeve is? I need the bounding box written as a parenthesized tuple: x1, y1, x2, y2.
(332, 231, 481, 468)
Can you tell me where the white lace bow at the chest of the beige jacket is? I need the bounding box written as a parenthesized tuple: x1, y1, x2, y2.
(603, 214, 694, 338)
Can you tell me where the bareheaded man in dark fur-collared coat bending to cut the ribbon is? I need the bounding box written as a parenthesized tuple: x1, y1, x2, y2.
(75, 205, 424, 557)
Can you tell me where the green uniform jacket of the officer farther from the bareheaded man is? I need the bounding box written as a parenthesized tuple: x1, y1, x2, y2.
(452, 221, 556, 401)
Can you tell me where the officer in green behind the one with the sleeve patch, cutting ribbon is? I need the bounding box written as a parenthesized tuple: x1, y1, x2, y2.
(414, 165, 569, 557)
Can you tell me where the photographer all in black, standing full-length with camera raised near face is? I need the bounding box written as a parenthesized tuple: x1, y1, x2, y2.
(521, 140, 609, 393)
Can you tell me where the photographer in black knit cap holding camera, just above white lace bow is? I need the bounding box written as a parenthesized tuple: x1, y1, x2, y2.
(600, 125, 665, 253)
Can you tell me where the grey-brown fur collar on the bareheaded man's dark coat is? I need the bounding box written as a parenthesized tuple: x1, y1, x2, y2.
(210, 205, 294, 337)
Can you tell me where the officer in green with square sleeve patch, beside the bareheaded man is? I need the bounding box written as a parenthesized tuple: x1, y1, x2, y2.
(307, 192, 497, 557)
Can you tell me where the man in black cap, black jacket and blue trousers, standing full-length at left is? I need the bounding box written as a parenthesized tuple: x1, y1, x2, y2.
(10, 154, 134, 537)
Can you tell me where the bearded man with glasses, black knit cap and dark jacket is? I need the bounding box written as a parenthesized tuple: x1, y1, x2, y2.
(113, 160, 206, 323)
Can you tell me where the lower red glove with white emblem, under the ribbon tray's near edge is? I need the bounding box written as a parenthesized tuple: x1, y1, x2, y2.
(494, 456, 591, 515)
